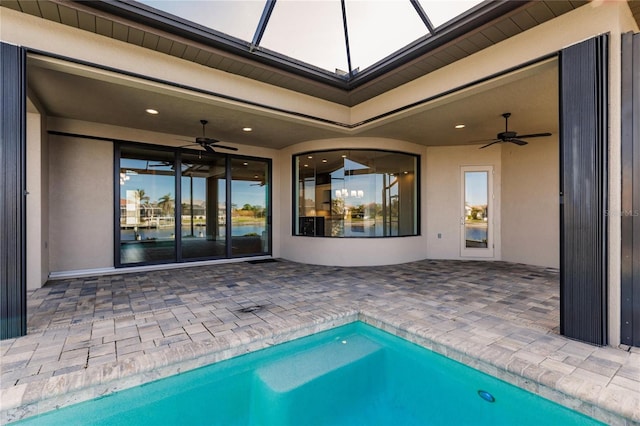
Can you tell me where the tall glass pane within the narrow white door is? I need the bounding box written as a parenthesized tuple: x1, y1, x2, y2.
(464, 172, 489, 248)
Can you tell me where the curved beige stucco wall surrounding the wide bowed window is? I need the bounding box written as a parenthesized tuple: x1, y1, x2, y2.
(274, 138, 428, 266)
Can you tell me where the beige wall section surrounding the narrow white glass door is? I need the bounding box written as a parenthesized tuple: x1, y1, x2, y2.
(423, 145, 502, 260)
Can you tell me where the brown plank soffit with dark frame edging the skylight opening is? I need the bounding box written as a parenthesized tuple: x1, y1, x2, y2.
(2, 0, 587, 106)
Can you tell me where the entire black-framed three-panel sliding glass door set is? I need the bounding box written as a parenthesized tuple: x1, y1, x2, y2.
(116, 143, 271, 266)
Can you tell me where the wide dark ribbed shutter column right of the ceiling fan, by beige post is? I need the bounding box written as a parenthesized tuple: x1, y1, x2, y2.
(560, 35, 609, 345)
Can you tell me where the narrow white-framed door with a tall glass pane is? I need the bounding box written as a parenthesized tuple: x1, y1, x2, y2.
(460, 166, 494, 258)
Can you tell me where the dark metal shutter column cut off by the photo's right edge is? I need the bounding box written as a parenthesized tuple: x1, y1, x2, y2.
(616, 33, 640, 346)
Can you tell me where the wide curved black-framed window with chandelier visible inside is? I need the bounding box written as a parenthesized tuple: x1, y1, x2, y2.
(293, 150, 419, 237)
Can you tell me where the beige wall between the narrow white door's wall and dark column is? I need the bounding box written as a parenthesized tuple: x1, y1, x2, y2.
(502, 136, 560, 268)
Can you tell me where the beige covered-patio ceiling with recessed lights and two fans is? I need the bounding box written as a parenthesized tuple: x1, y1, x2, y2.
(27, 54, 558, 153)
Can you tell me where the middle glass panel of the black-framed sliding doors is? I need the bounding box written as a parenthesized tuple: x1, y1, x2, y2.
(181, 153, 227, 259)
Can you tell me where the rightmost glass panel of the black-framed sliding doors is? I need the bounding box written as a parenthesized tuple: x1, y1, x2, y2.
(231, 158, 270, 255)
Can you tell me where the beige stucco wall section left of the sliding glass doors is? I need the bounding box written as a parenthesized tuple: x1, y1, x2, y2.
(49, 136, 113, 272)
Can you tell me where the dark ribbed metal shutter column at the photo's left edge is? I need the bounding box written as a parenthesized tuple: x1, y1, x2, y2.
(0, 43, 27, 339)
